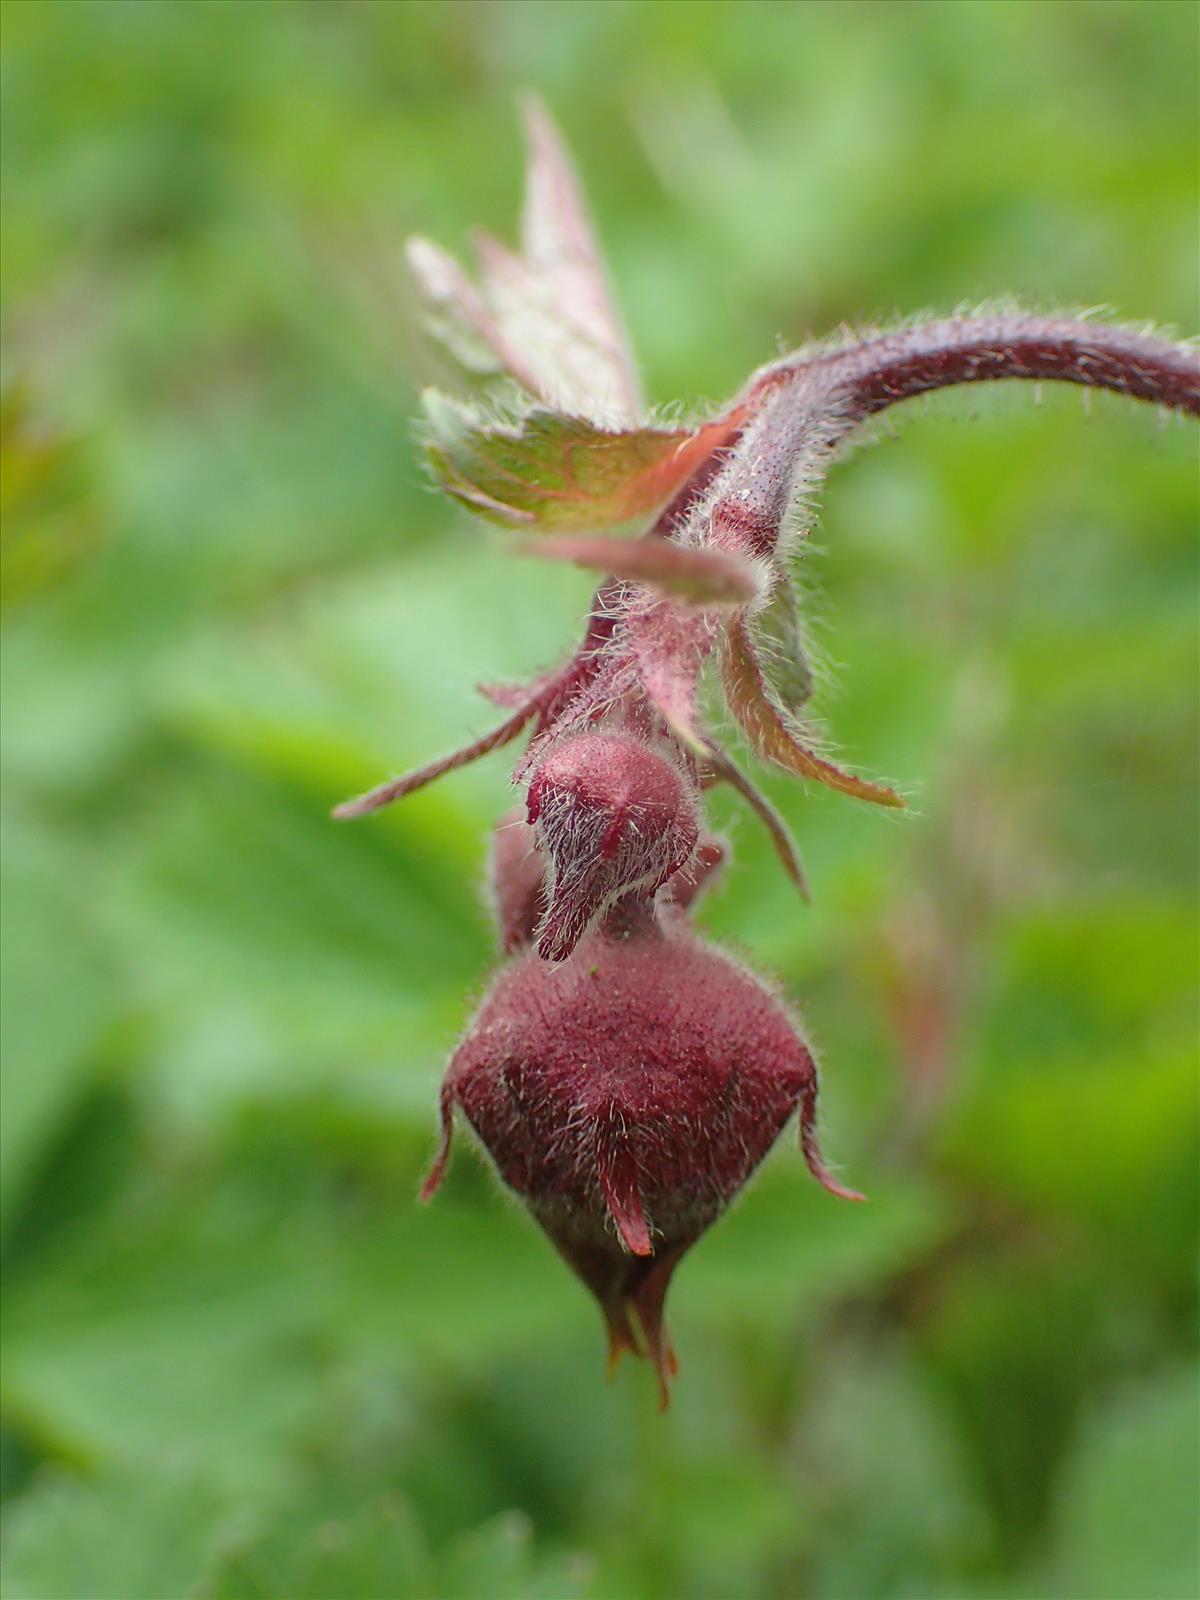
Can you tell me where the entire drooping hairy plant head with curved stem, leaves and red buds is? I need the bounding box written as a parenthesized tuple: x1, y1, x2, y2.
(334, 102, 1200, 1397)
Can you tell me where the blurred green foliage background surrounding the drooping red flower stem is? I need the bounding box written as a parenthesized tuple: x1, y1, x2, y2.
(0, 0, 1197, 1600)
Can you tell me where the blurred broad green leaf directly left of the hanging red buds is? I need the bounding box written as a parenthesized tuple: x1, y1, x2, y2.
(96, 758, 488, 1126)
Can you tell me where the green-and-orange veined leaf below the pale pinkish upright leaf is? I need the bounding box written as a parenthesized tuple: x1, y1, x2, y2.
(424, 390, 730, 533)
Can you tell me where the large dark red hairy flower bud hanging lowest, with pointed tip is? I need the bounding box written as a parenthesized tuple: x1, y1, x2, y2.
(422, 898, 862, 1405)
